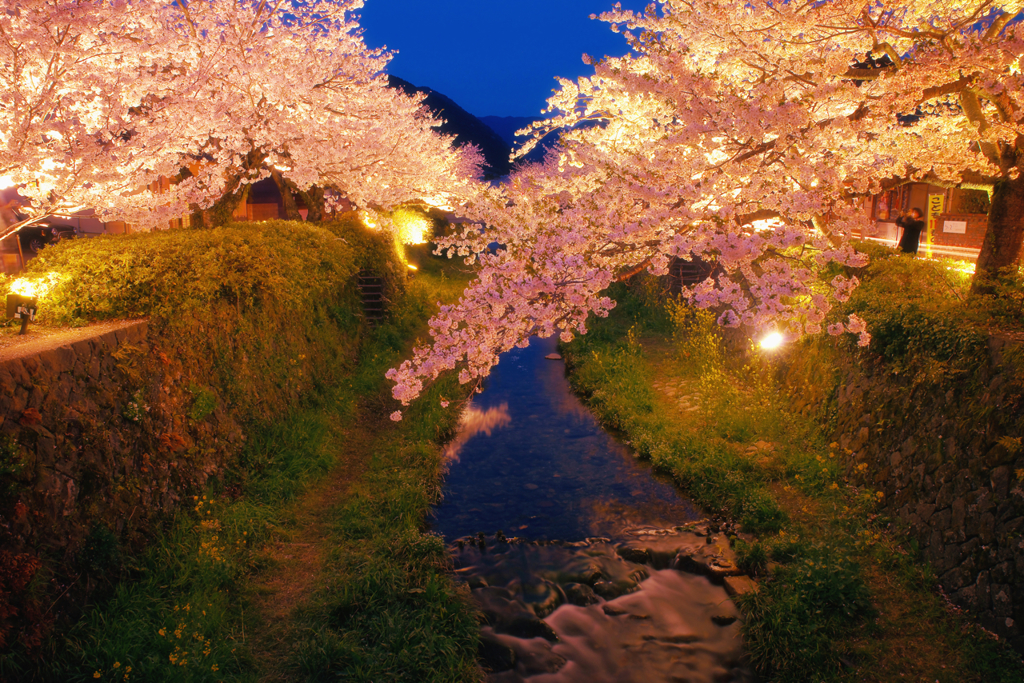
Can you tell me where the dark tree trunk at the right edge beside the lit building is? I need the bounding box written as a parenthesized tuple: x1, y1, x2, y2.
(971, 173, 1024, 294)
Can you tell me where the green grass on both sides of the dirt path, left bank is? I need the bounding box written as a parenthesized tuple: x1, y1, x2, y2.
(9, 244, 477, 683)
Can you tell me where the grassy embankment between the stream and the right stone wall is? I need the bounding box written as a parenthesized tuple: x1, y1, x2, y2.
(566, 259, 1024, 683)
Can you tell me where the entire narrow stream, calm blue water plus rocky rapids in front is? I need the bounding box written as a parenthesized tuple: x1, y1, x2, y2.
(433, 338, 754, 683)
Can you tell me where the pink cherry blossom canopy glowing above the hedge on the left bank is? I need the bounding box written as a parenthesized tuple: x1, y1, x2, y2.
(0, 0, 480, 237)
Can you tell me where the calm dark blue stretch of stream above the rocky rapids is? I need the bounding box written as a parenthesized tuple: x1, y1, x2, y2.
(433, 338, 698, 541)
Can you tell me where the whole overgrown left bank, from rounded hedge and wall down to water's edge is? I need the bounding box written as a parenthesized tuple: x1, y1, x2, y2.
(0, 219, 477, 681)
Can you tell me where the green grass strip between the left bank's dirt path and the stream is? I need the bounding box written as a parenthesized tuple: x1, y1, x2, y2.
(286, 246, 478, 682)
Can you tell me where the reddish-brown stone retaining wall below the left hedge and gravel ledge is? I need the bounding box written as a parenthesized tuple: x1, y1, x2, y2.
(0, 321, 251, 651)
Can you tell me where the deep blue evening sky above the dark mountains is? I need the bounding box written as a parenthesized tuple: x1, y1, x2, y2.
(361, 0, 647, 116)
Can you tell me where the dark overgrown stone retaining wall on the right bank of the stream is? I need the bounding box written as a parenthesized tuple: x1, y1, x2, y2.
(781, 338, 1024, 652)
